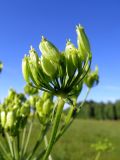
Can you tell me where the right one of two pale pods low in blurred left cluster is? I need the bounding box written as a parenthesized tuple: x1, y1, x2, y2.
(5, 111, 16, 129)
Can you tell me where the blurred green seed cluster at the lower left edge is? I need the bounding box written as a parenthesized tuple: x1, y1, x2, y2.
(0, 89, 30, 136)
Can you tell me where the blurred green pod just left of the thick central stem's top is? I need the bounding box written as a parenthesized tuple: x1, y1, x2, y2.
(43, 99, 52, 115)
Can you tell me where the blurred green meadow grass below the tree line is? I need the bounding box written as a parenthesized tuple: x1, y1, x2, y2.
(0, 119, 120, 160)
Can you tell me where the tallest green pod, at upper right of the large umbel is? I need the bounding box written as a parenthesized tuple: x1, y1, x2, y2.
(76, 25, 91, 53)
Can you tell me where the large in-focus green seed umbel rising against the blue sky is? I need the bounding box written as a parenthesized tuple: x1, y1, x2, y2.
(22, 25, 92, 98)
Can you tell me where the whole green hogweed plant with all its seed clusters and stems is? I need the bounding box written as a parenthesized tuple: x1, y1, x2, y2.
(0, 25, 99, 160)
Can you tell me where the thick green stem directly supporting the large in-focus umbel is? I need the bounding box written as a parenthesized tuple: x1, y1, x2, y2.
(43, 98, 64, 160)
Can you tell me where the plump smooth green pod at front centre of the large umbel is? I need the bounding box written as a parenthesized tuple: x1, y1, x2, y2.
(41, 57, 58, 78)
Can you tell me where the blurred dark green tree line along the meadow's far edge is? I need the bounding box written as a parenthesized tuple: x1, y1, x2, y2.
(65, 100, 120, 120)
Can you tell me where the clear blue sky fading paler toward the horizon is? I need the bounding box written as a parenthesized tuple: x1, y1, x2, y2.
(0, 0, 120, 101)
